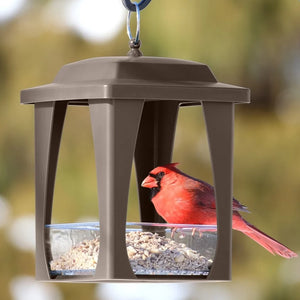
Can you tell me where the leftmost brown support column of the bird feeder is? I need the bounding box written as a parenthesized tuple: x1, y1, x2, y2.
(35, 101, 67, 280)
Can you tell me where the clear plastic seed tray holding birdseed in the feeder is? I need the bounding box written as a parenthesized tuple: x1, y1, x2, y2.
(46, 222, 217, 276)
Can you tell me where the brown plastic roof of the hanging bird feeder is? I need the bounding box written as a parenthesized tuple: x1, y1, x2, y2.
(21, 56, 250, 104)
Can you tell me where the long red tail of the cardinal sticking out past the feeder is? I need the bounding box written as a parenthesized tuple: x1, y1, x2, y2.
(239, 220, 298, 258)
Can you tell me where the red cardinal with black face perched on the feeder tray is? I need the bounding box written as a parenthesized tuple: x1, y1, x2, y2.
(142, 163, 298, 258)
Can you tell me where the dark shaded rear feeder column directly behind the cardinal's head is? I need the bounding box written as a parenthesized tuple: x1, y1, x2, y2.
(135, 100, 179, 223)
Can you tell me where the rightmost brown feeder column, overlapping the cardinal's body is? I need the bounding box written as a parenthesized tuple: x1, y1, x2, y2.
(202, 102, 234, 280)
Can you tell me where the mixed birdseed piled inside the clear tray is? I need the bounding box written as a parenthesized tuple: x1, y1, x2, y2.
(50, 231, 212, 275)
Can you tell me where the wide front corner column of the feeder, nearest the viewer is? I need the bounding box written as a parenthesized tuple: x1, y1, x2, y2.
(89, 99, 144, 279)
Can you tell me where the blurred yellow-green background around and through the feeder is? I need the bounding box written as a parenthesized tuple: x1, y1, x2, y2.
(0, 0, 300, 300)
